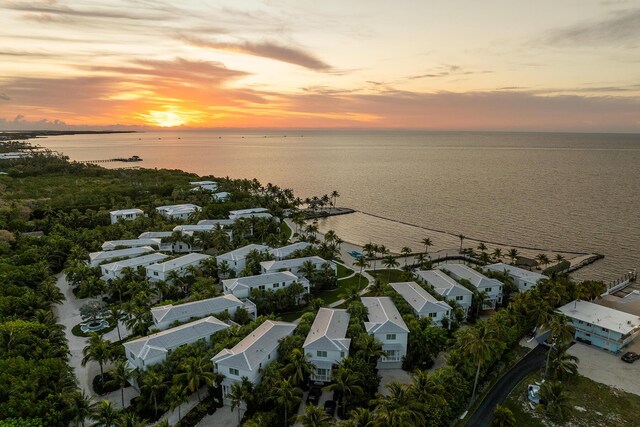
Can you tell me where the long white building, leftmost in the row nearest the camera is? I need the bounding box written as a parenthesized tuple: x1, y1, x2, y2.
(123, 317, 229, 371)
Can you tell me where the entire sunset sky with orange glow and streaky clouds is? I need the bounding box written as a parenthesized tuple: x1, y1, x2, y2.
(0, 0, 640, 133)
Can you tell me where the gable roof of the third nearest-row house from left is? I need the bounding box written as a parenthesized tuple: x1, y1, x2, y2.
(302, 307, 351, 352)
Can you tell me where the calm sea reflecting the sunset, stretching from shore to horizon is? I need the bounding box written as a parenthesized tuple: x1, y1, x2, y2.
(38, 130, 640, 280)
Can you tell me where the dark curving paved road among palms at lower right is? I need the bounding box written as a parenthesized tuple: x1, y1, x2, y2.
(466, 345, 547, 427)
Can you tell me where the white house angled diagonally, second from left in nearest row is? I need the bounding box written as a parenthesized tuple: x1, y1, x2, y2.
(211, 320, 296, 405)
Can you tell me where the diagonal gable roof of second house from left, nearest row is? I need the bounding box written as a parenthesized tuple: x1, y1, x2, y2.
(211, 320, 296, 371)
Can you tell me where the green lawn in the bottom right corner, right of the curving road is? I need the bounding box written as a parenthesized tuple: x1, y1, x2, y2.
(504, 373, 640, 427)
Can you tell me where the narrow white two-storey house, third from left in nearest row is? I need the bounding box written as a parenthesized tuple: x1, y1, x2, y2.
(302, 307, 351, 382)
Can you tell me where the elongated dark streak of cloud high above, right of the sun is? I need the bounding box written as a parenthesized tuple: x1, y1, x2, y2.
(178, 35, 331, 71)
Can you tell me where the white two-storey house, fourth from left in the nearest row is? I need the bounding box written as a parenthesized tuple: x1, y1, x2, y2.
(360, 297, 409, 369)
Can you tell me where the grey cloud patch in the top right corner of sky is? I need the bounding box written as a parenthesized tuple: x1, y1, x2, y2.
(546, 8, 640, 48)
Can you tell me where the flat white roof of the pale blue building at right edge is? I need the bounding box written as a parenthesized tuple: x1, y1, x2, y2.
(558, 300, 640, 335)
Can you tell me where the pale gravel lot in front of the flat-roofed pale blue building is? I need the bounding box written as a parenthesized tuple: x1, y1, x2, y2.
(567, 339, 640, 395)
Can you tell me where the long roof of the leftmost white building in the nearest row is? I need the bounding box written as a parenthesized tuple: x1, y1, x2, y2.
(123, 317, 229, 360)
